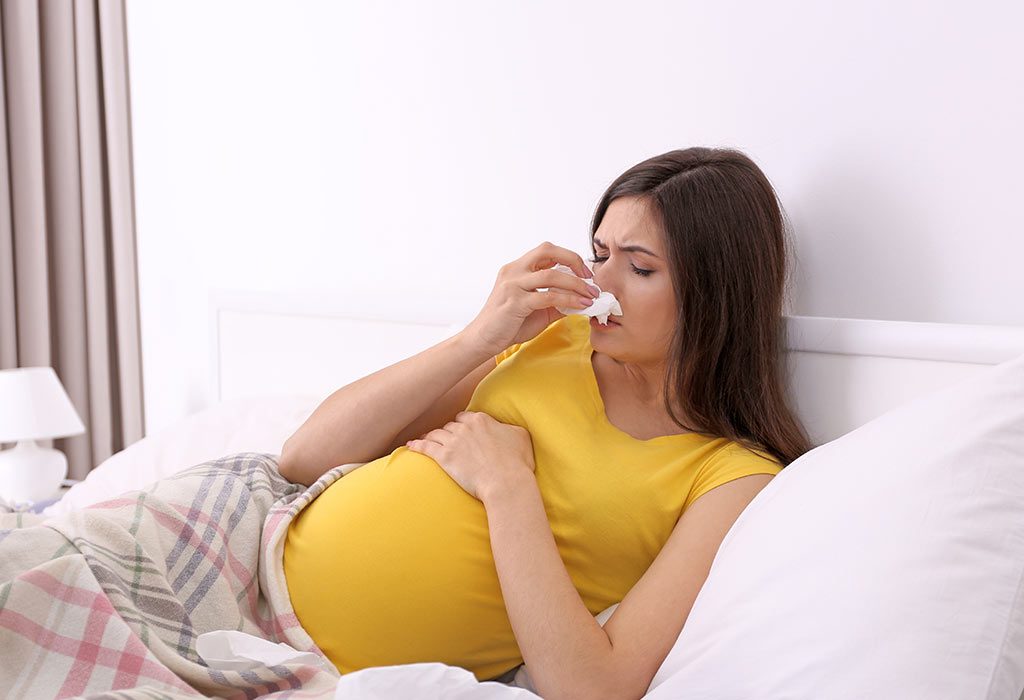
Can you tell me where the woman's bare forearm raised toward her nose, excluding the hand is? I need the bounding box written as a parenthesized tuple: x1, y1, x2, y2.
(280, 332, 501, 484)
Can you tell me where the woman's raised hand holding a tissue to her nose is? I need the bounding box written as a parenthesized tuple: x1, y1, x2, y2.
(462, 240, 594, 355)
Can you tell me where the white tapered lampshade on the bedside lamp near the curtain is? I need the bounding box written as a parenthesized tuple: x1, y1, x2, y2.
(0, 367, 85, 442)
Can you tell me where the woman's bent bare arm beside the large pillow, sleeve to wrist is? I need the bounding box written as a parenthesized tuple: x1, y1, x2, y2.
(481, 469, 774, 700)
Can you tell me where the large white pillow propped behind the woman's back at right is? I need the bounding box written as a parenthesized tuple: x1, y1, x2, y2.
(645, 355, 1024, 700)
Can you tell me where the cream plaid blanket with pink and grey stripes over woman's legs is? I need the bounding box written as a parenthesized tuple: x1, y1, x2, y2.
(0, 452, 350, 698)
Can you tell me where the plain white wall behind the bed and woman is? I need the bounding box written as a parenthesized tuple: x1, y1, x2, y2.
(128, 0, 1024, 432)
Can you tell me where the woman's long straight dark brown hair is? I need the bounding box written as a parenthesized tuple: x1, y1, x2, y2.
(590, 146, 811, 466)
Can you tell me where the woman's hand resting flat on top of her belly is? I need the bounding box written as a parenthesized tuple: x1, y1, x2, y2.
(406, 410, 536, 501)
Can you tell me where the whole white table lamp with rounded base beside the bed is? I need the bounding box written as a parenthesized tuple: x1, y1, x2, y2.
(0, 367, 85, 505)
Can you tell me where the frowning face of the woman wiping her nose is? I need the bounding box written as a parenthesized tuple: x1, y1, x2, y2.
(590, 195, 676, 368)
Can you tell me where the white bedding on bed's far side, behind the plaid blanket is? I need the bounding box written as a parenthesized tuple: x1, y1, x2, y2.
(43, 395, 324, 516)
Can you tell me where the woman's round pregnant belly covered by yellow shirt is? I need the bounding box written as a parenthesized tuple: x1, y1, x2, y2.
(284, 447, 522, 681)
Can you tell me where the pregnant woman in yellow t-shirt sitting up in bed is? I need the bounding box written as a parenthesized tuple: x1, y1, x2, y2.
(280, 147, 810, 698)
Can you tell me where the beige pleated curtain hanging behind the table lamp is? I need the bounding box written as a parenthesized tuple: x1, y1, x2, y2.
(0, 0, 143, 479)
